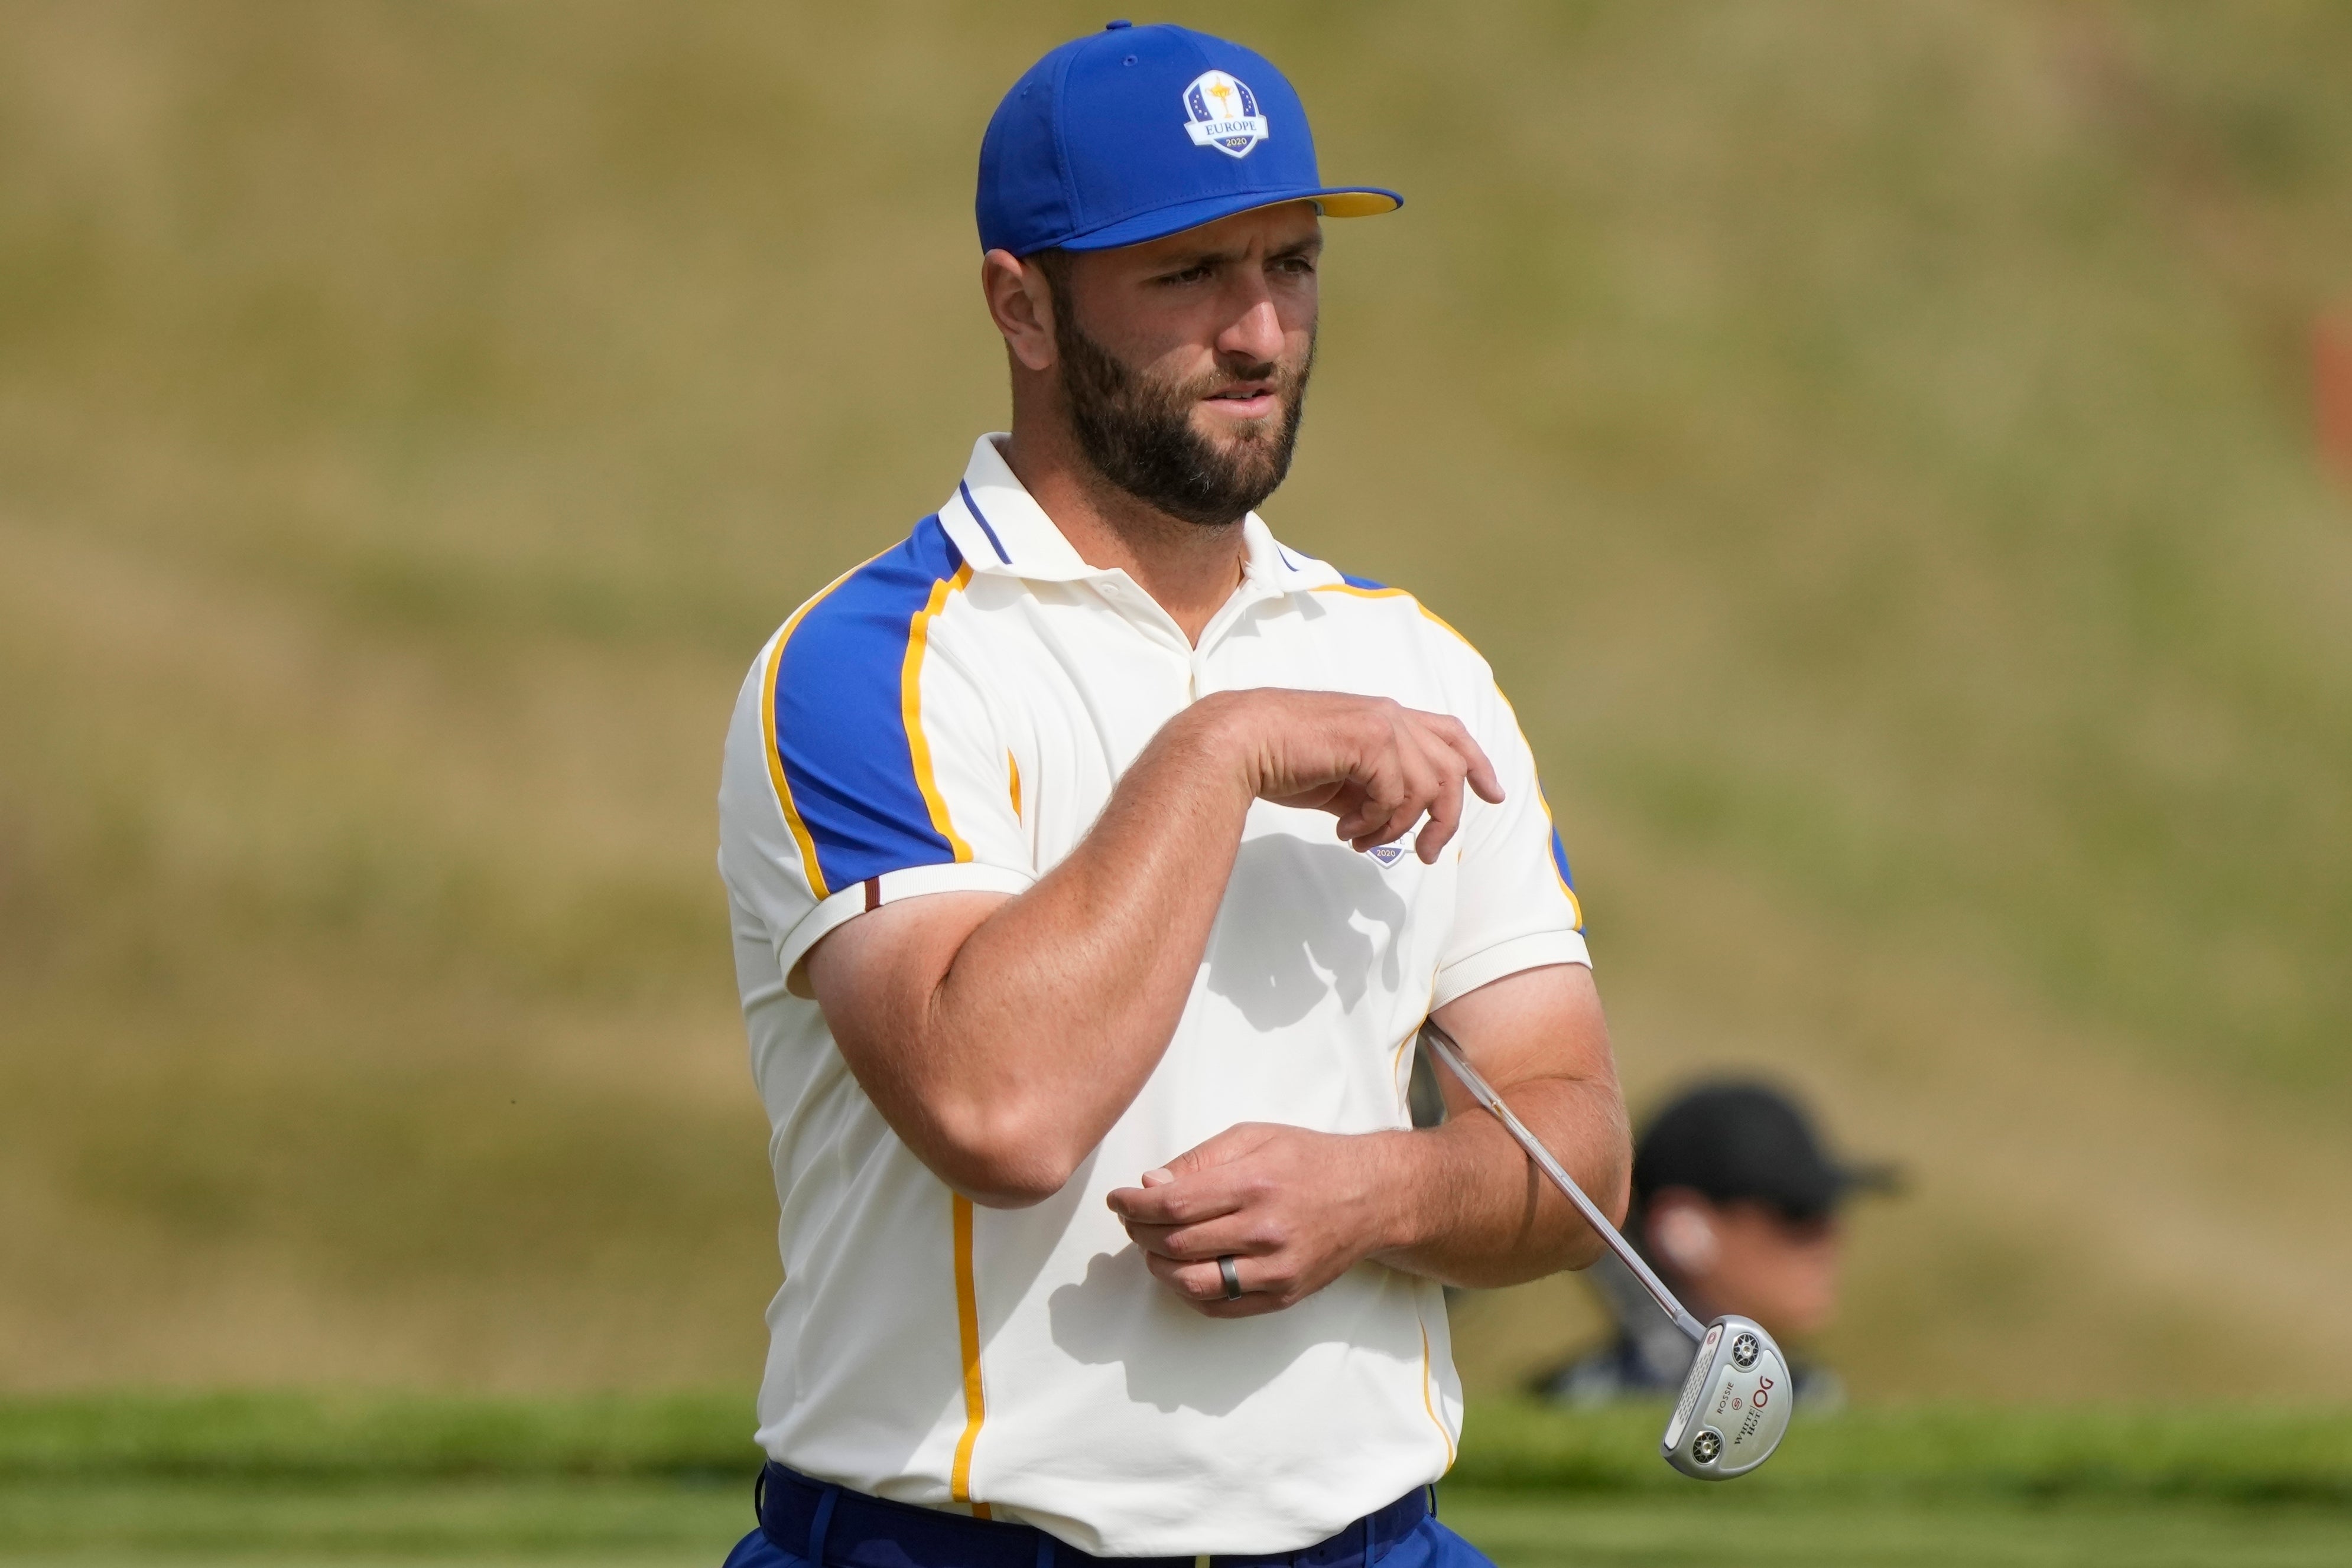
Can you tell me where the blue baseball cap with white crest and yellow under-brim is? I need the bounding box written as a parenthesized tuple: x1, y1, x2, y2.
(976, 21, 1404, 256)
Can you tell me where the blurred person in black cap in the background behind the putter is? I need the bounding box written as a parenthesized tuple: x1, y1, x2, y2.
(1536, 1081, 1893, 1410)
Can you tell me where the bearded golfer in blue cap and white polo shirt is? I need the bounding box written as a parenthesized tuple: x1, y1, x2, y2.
(720, 21, 1627, 1568)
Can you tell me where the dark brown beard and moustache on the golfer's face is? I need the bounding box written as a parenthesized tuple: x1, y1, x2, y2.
(1054, 310, 1315, 529)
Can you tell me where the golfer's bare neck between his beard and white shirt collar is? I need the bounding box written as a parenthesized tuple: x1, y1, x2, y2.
(1004, 421, 1249, 644)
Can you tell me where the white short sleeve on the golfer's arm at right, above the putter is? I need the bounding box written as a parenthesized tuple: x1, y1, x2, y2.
(1430, 684, 1592, 1009)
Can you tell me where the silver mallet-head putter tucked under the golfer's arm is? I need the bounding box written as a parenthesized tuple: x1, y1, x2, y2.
(1421, 1020, 1795, 1481)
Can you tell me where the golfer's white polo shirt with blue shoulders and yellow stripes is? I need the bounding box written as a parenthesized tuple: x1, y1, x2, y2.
(720, 437, 1588, 1556)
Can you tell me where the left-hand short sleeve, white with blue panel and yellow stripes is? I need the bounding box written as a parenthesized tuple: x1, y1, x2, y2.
(720, 519, 1037, 990)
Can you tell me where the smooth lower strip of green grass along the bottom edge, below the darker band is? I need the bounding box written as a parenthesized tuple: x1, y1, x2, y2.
(0, 1479, 2352, 1568)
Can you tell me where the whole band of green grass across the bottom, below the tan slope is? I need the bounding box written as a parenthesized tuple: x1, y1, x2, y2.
(0, 1394, 2352, 1568)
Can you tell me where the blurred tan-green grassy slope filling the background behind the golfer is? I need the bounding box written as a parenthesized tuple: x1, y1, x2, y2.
(0, 0, 2352, 1420)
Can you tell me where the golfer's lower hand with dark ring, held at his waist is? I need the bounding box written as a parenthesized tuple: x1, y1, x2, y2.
(1108, 1121, 1411, 1316)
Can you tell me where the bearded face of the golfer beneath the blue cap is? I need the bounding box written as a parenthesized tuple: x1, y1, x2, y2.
(1054, 202, 1322, 526)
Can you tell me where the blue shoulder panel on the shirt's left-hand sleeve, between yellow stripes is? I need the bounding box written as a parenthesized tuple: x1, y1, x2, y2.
(774, 515, 964, 893)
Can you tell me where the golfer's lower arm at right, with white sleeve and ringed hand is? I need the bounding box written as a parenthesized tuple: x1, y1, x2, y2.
(1110, 687, 1632, 1316)
